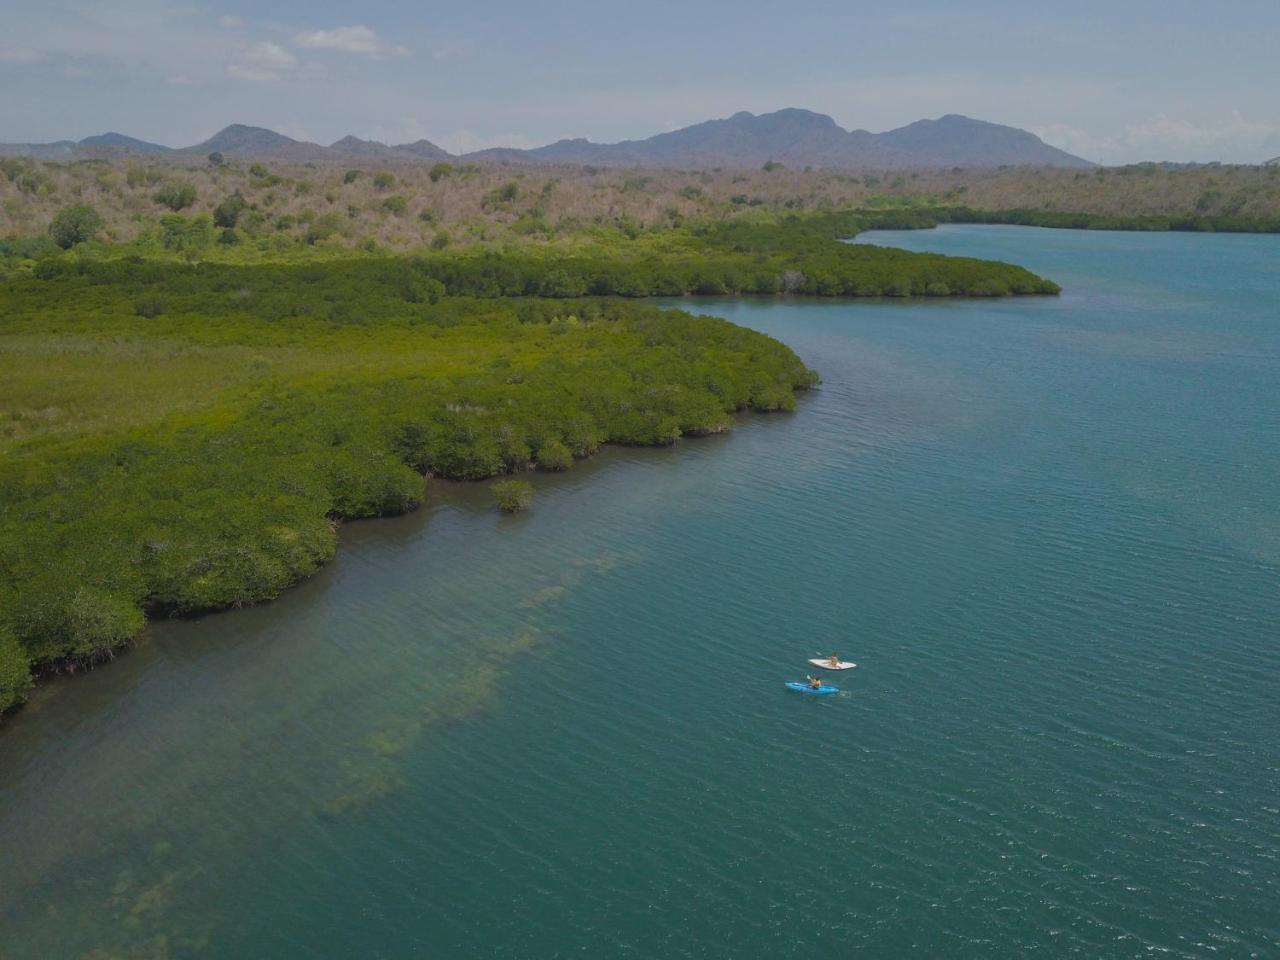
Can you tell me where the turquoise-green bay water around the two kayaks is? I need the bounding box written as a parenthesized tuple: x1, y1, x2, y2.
(0, 227, 1280, 960)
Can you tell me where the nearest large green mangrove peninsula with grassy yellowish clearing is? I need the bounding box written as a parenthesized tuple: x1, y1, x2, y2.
(0, 273, 815, 704)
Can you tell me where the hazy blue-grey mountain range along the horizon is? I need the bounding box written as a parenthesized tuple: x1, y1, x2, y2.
(0, 108, 1093, 170)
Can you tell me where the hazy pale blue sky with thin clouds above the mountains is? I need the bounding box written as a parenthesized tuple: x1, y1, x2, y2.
(0, 0, 1280, 164)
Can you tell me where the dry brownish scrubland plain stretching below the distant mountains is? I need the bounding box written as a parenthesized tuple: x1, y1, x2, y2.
(0, 157, 1280, 250)
